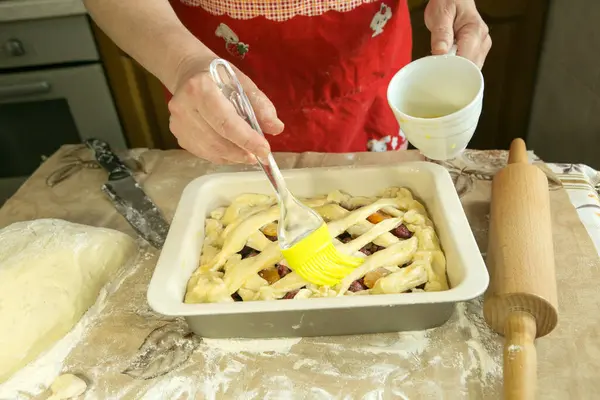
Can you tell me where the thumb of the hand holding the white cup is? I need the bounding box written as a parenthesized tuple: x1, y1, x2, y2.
(425, 0, 456, 54)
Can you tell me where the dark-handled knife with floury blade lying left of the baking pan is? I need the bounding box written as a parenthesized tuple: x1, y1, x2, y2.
(85, 139, 169, 250)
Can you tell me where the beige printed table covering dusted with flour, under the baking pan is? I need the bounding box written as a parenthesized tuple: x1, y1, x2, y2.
(0, 147, 600, 400)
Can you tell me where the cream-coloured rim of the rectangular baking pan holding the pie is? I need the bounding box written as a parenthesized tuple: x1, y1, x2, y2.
(147, 161, 489, 317)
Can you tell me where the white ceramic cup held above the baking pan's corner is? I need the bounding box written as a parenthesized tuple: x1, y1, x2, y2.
(387, 55, 484, 160)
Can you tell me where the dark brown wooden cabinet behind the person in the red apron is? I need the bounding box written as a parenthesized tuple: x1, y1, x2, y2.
(95, 0, 549, 149)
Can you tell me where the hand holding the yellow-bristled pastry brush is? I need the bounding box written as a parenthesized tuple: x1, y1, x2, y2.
(169, 57, 284, 164)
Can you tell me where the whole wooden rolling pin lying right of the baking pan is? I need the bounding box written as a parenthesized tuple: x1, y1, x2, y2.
(483, 139, 558, 400)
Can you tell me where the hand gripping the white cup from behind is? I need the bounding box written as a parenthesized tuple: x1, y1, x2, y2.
(425, 0, 492, 68)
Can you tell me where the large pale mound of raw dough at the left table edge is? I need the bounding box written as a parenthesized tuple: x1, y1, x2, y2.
(0, 219, 137, 383)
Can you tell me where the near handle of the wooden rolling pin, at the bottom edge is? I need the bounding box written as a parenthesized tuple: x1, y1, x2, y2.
(504, 311, 537, 400)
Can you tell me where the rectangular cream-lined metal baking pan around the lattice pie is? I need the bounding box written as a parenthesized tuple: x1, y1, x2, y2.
(148, 162, 489, 338)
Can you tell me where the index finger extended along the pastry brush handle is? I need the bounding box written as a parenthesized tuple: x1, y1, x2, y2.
(187, 74, 270, 157)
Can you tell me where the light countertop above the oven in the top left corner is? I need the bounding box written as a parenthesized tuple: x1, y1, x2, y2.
(0, 0, 87, 22)
